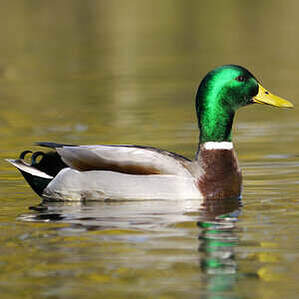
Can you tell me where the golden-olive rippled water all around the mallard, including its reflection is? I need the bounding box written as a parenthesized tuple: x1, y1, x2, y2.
(0, 0, 299, 299)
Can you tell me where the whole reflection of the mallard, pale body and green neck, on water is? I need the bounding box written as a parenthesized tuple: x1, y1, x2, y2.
(22, 199, 246, 299)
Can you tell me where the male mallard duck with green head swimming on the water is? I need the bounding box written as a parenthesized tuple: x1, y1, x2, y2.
(7, 64, 293, 201)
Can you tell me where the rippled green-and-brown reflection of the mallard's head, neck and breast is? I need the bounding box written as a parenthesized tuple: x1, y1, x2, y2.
(197, 199, 245, 299)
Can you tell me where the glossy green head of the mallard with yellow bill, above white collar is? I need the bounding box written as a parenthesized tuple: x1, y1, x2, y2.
(196, 65, 293, 143)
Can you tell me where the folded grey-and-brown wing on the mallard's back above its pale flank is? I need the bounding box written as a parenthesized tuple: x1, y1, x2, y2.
(45, 144, 191, 176)
